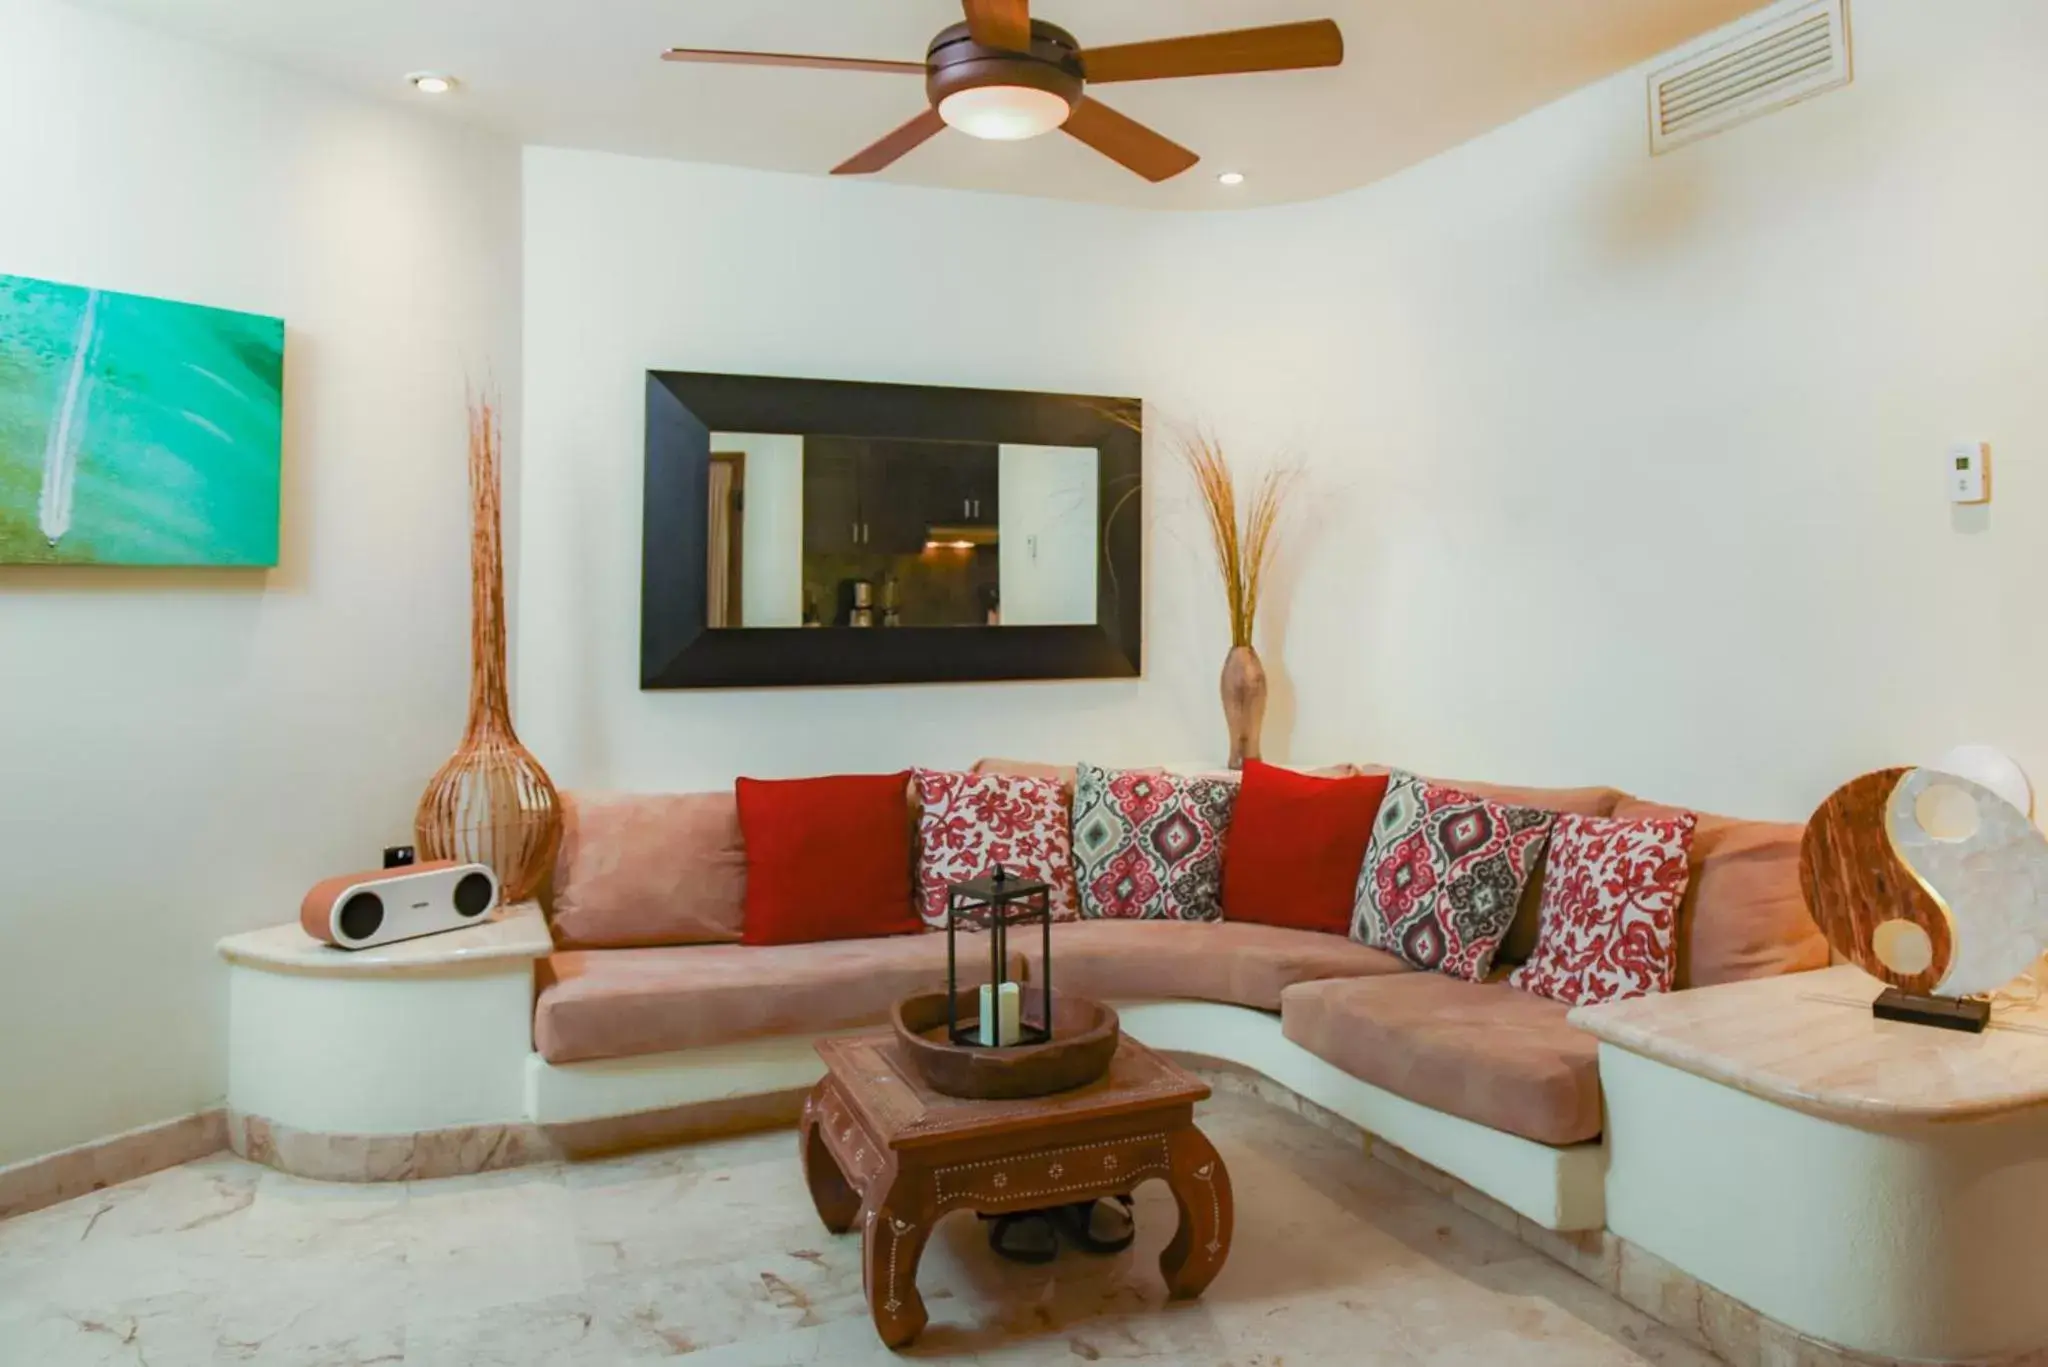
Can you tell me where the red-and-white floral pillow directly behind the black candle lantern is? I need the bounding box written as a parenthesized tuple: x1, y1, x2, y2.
(915, 769, 1079, 928)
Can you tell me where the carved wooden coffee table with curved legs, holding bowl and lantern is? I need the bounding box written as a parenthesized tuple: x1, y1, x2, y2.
(797, 1035, 1231, 1349)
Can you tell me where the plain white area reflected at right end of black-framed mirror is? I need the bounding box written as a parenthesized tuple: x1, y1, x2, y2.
(995, 447, 1102, 627)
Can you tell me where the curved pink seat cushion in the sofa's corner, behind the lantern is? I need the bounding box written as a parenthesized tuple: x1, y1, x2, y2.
(1010, 920, 1409, 1010)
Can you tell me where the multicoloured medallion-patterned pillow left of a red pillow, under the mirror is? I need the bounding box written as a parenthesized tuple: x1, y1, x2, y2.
(1073, 764, 1237, 920)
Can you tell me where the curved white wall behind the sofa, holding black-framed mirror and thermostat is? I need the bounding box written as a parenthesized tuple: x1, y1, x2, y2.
(518, 0, 2048, 818)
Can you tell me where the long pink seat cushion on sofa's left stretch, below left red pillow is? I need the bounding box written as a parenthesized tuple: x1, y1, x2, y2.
(532, 935, 1022, 1064)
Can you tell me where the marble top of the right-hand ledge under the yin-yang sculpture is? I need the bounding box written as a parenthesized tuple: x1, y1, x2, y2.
(1571, 965, 2048, 1129)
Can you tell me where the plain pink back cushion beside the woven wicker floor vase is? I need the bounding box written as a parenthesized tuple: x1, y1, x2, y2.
(547, 791, 748, 949)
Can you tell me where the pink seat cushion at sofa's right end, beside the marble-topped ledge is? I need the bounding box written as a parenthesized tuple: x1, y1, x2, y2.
(1277, 965, 1599, 1146)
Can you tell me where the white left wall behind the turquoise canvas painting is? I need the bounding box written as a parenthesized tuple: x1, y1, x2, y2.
(0, 0, 520, 1164)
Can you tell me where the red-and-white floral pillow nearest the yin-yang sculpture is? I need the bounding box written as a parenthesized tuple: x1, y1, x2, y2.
(1507, 812, 1700, 1006)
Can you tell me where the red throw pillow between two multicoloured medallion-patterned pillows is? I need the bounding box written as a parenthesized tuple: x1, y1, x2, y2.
(1223, 760, 1386, 935)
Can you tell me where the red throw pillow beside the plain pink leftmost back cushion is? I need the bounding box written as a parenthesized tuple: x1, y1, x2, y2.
(733, 771, 924, 945)
